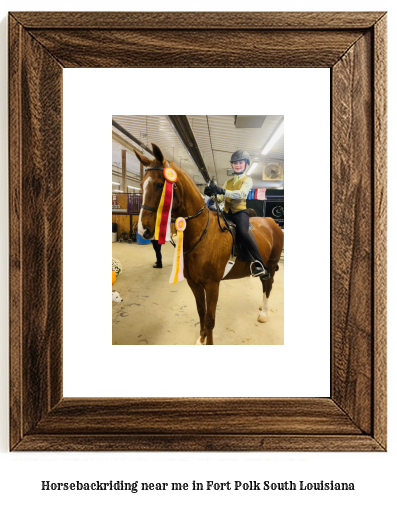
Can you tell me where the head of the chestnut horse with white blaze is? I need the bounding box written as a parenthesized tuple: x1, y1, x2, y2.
(134, 143, 167, 239)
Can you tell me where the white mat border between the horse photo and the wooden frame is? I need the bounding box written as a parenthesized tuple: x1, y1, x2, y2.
(63, 69, 330, 397)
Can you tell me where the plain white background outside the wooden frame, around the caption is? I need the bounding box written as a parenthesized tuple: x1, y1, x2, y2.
(0, 0, 397, 506)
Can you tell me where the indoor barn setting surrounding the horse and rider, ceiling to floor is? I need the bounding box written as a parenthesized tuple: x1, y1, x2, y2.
(112, 115, 284, 345)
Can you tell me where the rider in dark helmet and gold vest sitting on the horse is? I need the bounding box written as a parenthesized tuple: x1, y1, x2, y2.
(204, 150, 270, 280)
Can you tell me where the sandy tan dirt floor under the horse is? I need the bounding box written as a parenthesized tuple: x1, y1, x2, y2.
(112, 242, 284, 345)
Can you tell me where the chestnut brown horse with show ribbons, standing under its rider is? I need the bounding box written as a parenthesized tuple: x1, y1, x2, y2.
(135, 144, 284, 345)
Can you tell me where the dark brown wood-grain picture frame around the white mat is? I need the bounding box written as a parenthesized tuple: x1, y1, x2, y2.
(9, 12, 386, 451)
